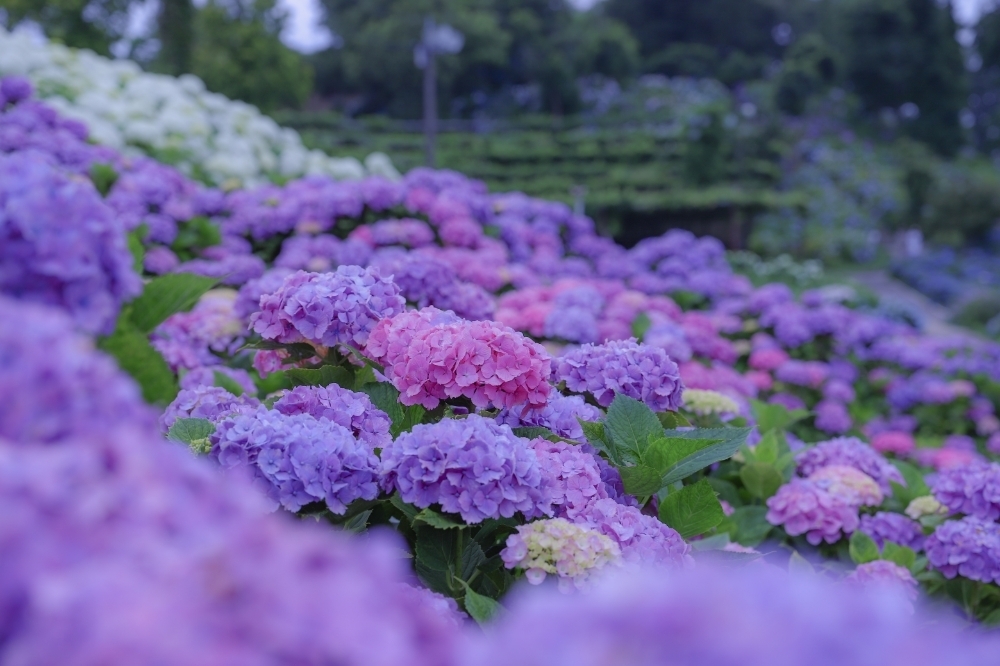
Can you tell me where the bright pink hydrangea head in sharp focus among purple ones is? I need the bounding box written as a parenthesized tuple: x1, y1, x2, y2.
(367, 310, 551, 410)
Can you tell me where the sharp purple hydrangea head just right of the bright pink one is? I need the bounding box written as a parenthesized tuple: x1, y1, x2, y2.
(552, 338, 684, 412)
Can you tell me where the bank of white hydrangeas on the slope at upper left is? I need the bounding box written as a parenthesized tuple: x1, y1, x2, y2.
(0, 26, 400, 186)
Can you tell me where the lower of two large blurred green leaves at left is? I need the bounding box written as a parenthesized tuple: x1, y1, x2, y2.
(97, 316, 177, 405)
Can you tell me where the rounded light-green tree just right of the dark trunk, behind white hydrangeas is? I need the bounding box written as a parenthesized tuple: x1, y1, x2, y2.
(191, 0, 312, 112)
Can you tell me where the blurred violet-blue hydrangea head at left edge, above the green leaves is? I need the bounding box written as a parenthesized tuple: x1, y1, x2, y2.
(0, 151, 142, 334)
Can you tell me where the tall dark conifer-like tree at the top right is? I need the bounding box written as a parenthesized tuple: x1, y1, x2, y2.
(845, 0, 968, 155)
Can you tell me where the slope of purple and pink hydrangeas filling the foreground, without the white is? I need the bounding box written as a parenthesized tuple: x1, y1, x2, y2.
(9, 53, 1000, 666)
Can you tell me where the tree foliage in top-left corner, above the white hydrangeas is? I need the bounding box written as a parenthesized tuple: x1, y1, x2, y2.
(0, 0, 131, 55)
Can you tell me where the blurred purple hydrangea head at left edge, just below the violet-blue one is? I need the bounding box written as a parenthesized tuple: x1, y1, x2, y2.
(0, 296, 155, 442)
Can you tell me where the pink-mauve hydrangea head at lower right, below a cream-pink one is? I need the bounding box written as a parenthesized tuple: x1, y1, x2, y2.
(767, 478, 859, 546)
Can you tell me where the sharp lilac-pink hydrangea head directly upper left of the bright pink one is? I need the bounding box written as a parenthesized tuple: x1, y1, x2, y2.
(250, 266, 406, 347)
